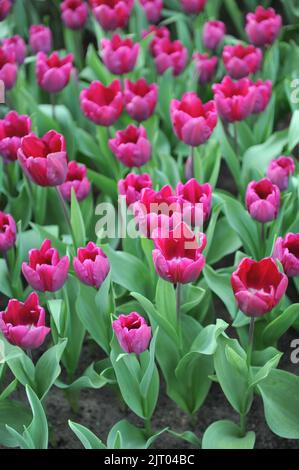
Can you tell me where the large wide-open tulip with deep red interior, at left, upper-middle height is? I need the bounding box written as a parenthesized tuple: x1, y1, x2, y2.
(18, 131, 67, 186)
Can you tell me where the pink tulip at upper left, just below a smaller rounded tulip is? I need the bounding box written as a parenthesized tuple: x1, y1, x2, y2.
(36, 52, 73, 93)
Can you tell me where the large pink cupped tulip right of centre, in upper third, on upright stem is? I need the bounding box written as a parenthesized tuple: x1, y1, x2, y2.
(170, 92, 217, 147)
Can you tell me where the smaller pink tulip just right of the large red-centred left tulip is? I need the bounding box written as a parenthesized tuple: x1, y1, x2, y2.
(59, 160, 90, 201)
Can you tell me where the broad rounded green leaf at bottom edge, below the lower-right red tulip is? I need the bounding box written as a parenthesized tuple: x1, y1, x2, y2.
(202, 420, 255, 449)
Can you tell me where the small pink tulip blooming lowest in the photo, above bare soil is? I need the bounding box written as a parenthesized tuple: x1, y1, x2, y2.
(112, 312, 152, 354)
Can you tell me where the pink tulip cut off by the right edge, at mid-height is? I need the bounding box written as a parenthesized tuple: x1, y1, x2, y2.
(273, 233, 299, 277)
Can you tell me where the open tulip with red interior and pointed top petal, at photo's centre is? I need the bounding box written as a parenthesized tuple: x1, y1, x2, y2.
(153, 223, 206, 284)
